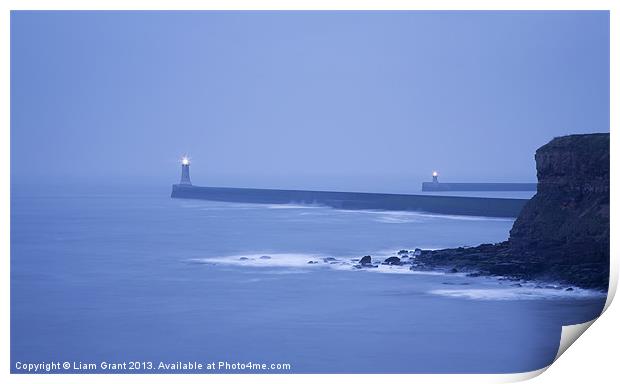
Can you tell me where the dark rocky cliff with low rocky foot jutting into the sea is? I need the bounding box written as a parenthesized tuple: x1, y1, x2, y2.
(419, 134, 610, 289)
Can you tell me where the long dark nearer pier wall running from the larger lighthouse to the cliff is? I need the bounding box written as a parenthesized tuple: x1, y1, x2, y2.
(171, 184, 528, 217)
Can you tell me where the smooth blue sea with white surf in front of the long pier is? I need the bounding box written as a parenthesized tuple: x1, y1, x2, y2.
(11, 190, 605, 373)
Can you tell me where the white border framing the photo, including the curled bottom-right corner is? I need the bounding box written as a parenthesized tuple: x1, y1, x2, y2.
(0, 0, 620, 383)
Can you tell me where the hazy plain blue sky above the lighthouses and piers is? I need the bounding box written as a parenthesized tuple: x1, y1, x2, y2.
(11, 11, 609, 193)
